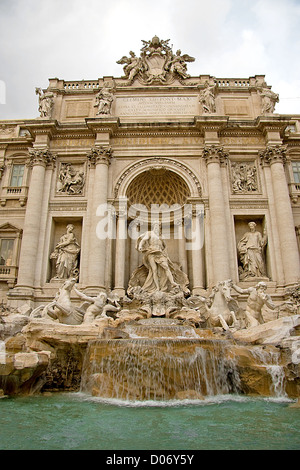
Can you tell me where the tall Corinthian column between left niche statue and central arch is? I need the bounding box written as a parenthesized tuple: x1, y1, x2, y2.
(87, 146, 111, 289)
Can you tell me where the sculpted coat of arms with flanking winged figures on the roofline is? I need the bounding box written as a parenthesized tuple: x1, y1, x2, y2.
(117, 36, 195, 85)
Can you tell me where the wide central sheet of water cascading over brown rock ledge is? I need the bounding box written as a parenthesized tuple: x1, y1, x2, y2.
(81, 319, 243, 400)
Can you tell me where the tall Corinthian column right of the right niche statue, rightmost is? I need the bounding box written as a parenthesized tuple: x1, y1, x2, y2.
(260, 145, 300, 284)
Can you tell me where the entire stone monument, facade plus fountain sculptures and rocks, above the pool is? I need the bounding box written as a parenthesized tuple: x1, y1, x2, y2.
(0, 36, 300, 400)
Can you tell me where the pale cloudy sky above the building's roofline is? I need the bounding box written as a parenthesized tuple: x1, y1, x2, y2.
(0, 0, 300, 120)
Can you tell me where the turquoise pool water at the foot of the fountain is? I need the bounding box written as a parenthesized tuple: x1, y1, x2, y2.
(0, 393, 300, 450)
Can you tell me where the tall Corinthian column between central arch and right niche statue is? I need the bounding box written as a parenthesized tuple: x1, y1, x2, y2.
(203, 145, 231, 283)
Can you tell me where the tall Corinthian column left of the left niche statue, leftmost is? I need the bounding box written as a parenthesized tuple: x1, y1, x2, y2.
(16, 149, 55, 288)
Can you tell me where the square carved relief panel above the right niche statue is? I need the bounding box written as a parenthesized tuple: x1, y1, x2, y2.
(231, 162, 258, 194)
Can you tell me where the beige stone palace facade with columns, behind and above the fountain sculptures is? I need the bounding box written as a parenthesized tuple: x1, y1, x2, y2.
(0, 37, 300, 307)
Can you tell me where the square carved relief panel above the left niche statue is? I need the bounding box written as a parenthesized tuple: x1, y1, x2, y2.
(56, 163, 85, 194)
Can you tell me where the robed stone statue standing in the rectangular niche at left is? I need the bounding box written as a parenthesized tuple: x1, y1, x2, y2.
(50, 224, 80, 279)
